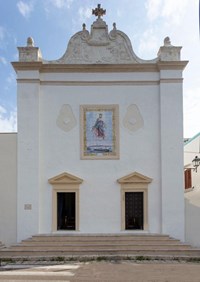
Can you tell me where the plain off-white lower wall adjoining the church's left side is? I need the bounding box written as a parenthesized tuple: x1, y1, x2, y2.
(0, 133, 17, 245)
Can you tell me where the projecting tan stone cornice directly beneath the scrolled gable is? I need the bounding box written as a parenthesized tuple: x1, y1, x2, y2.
(12, 61, 188, 73)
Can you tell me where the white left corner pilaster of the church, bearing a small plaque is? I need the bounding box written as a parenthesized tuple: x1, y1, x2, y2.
(17, 77, 41, 241)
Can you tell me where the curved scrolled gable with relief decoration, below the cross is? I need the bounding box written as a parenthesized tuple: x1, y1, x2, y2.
(54, 18, 156, 64)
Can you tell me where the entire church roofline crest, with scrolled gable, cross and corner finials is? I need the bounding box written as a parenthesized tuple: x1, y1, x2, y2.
(15, 4, 184, 66)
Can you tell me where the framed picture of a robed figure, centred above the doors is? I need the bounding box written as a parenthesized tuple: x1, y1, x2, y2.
(80, 104, 119, 160)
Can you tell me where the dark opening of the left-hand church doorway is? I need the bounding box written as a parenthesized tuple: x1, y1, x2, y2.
(57, 192, 76, 230)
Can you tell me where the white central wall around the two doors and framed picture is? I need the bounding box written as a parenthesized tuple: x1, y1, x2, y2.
(41, 74, 160, 233)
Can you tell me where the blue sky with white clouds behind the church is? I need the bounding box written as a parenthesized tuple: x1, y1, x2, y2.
(0, 0, 200, 137)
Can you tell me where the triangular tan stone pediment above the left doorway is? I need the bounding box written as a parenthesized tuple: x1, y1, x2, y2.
(49, 172, 83, 184)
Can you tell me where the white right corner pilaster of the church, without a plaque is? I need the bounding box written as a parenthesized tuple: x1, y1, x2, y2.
(160, 76, 184, 241)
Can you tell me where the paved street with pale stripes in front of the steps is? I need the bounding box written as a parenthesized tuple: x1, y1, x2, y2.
(0, 261, 200, 282)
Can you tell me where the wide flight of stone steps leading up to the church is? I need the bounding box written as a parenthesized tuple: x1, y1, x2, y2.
(0, 234, 200, 257)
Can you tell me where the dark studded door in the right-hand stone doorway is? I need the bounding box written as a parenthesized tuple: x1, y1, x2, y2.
(125, 192, 144, 230)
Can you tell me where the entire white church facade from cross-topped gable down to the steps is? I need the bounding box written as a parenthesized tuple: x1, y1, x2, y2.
(0, 6, 187, 246)
